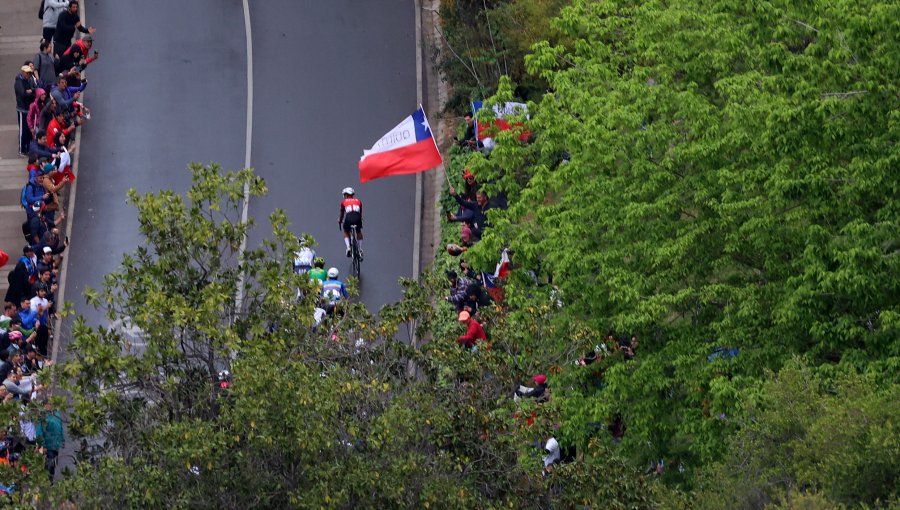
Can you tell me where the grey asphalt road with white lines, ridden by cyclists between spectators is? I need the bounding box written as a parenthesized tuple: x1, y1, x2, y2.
(65, 0, 416, 332)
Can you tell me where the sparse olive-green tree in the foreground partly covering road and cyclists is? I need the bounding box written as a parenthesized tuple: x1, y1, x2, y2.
(45, 165, 657, 508)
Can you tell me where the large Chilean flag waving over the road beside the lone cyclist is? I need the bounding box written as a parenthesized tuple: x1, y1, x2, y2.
(359, 106, 443, 182)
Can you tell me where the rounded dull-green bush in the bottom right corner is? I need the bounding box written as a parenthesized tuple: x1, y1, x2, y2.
(699, 363, 900, 508)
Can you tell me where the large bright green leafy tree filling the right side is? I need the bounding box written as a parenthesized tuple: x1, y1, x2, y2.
(454, 0, 900, 494)
